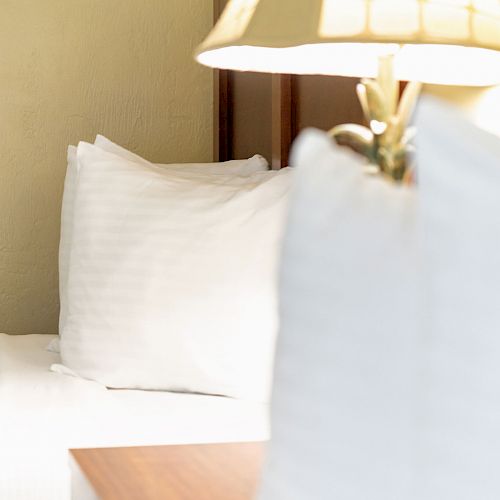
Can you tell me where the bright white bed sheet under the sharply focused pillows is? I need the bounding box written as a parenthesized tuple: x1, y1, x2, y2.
(0, 334, 269, 500)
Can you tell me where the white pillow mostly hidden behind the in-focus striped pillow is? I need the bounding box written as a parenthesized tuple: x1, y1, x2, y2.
(57, 135, 269, 340)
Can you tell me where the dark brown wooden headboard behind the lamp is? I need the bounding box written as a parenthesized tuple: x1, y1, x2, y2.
(214, 0, 363, 169)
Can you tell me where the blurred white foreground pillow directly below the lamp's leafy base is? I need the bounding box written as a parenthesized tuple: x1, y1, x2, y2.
(260, 130, 418, 500)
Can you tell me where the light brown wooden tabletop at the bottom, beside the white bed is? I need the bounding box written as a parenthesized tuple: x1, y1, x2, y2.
(70, 443, 264, 500)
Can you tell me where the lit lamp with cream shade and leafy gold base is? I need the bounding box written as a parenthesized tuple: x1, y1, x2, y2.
(196, 0, 500, 180)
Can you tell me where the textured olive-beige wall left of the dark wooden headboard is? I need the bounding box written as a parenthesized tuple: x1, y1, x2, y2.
(0, 0, 213, 333)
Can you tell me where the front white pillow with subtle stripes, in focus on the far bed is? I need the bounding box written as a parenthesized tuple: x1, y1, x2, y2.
(61, 143, 291, 400)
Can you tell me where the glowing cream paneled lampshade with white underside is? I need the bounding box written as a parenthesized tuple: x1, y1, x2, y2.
(196, 0, 500, 85)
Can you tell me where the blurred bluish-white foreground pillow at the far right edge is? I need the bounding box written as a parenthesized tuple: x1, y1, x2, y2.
(417, 98, 500, 500)
